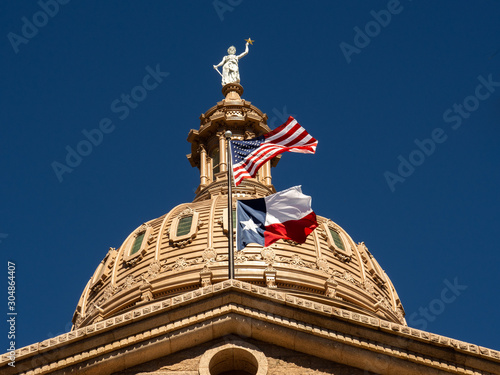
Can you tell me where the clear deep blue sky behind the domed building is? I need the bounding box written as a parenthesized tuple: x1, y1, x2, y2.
(0, 0, 500, 351)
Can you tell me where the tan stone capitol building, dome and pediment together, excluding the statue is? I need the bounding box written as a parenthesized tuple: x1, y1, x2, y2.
(6, 77, 500, 375)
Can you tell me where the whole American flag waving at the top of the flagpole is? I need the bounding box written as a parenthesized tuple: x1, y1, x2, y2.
(230, 116, 318, 186)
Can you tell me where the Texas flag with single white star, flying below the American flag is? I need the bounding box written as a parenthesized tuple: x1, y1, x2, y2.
(236, 186, 318, 250)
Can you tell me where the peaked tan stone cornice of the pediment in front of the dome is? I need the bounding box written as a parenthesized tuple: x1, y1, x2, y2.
(0, 280, 500, 375)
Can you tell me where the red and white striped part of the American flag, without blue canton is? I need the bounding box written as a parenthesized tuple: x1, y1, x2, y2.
(233, 116, 318, 186)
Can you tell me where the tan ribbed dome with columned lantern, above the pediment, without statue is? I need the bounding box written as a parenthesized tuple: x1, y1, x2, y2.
(73, 84, 406, 328)
